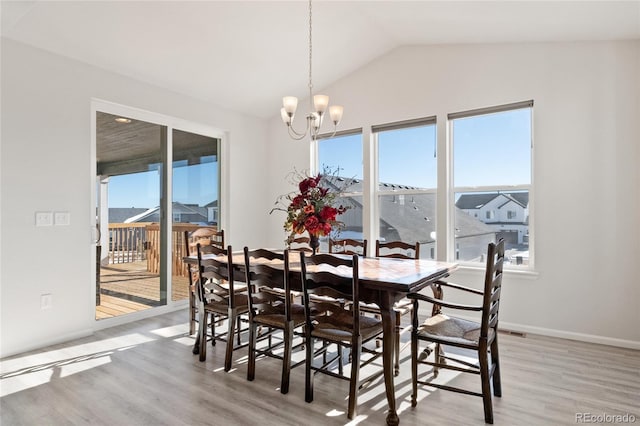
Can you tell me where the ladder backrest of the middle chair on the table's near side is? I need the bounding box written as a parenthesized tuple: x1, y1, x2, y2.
(244, 247, 291, 321)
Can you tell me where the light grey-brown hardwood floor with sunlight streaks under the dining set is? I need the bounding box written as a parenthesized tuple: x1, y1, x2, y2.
(0, 311, 640, 426)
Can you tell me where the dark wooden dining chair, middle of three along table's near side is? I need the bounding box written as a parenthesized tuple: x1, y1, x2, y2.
(244, 247, 305, 394)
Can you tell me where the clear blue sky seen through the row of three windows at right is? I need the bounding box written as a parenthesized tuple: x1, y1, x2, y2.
(319, 108, 531, 188)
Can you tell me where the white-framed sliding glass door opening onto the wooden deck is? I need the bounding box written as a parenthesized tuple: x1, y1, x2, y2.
(92, 101, 222, 320)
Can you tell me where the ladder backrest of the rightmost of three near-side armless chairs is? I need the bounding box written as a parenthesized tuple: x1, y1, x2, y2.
(300, 252, 360, 336)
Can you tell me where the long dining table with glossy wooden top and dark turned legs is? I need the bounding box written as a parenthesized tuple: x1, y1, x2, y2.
(183, 250, 457, 425)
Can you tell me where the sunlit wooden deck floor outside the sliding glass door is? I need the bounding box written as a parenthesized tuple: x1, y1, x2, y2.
(96, 261, 189, 319)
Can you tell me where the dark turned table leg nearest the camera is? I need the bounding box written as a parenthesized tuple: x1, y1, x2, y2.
(379, 292, 400, 426)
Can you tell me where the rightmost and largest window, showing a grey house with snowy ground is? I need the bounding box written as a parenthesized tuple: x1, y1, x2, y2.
(448, 102, 533, 265)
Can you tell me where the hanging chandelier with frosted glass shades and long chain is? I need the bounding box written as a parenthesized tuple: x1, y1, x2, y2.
(280, 0, 343, 140)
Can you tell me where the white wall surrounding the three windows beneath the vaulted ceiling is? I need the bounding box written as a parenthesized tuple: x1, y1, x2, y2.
(268, 41, 640, 348)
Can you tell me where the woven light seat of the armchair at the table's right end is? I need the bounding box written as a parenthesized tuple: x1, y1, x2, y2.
(417, 314, 495, 347)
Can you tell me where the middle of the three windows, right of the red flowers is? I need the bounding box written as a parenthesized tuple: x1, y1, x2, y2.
(372, 117, 437, 258)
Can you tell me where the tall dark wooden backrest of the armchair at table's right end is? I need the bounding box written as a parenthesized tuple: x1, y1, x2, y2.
(480, 239, 504, 338)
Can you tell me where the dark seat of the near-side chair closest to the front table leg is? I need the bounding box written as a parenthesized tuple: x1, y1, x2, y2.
(311, 312, 382, 343)
